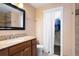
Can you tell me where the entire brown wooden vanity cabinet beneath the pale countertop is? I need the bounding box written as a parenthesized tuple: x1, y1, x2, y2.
(0, 39, 37, 56)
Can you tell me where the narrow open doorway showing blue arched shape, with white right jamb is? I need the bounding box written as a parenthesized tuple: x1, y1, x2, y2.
(53, 7, 63, 56)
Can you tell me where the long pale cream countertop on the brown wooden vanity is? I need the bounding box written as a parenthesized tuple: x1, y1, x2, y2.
(0, 36, 36, 50)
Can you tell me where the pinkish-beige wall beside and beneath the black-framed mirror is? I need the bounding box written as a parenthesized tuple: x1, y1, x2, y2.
(0, 4, 35, 37)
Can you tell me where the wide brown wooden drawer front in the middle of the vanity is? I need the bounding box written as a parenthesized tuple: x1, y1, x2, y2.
(9, 42, 26, 55)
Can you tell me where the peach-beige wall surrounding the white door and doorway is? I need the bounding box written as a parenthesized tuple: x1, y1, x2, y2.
(36, 3, 75, 56)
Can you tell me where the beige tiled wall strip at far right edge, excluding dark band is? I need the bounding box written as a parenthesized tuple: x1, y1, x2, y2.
(75, 4, 79, 56)
